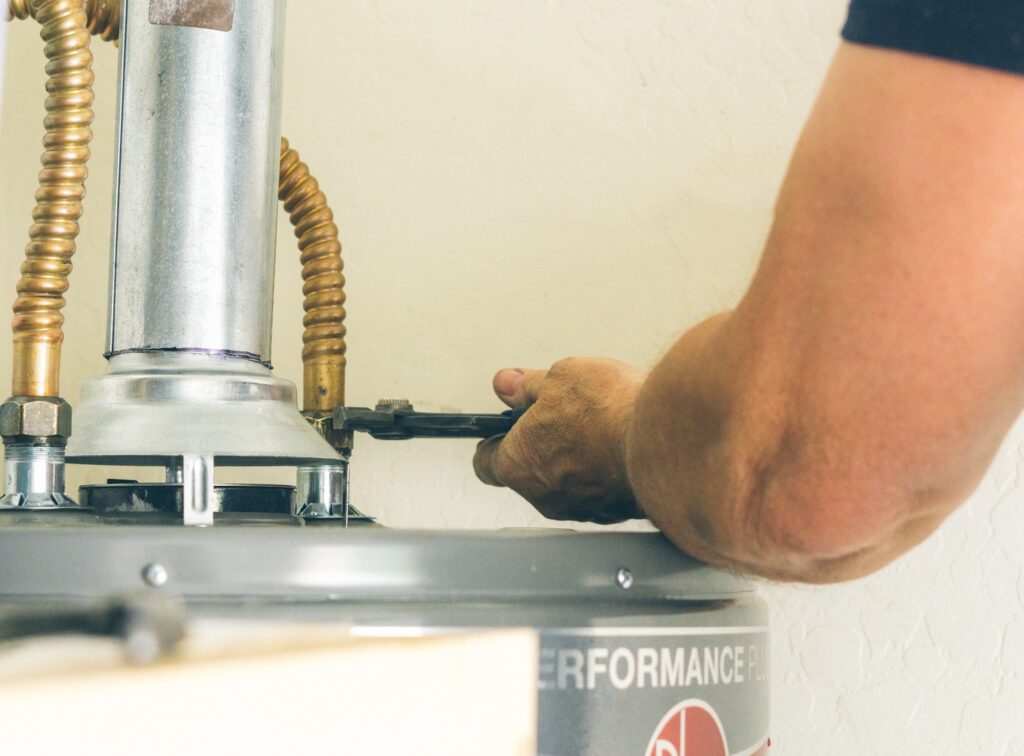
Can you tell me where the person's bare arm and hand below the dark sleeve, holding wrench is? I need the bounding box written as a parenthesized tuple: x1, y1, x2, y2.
(474, 43, 1024, 583)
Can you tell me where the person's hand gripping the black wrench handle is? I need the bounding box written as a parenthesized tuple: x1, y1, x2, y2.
(473, 358, 645, 522)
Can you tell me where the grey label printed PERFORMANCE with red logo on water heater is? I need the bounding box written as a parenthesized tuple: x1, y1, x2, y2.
(538, 627, 770, 756)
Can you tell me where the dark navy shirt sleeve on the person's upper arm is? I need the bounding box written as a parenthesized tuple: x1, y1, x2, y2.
(843, 0, 1024, 74)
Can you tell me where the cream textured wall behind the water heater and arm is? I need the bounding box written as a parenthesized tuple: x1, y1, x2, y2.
(0, 0, 1024, 756)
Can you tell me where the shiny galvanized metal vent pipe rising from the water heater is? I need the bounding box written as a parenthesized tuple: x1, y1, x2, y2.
(108, 0, 285, 364)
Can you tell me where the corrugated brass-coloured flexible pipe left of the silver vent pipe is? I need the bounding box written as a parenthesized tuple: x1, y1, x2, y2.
(9, 0, 93, 396)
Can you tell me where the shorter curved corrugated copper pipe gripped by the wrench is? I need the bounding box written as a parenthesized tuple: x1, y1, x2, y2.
(278, 139, 345, 413)
